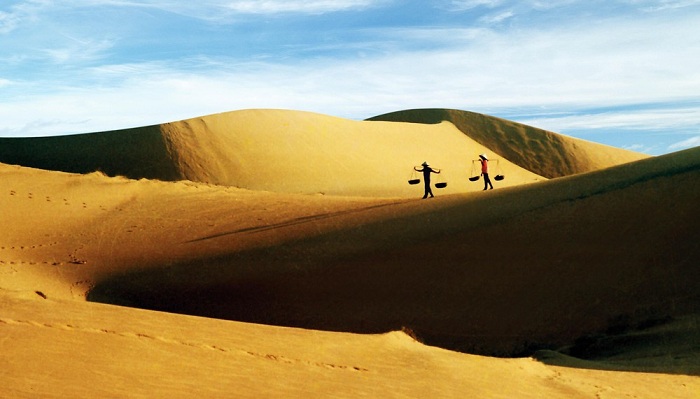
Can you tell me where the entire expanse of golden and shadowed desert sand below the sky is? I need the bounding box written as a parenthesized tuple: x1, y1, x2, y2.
(0, 110, 700, 398)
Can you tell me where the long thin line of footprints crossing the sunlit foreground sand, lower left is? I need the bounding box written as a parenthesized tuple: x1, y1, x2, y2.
(0, 318, 369, 372)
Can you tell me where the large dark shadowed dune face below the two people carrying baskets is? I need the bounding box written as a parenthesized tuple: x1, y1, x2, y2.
(88, 149, 700, 356)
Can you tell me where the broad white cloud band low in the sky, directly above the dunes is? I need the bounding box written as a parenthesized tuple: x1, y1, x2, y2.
(0, 41, 700, 139)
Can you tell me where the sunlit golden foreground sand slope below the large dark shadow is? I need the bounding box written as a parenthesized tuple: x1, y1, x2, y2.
(0, 290, 700, 398)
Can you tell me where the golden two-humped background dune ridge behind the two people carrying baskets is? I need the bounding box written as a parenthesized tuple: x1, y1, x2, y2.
(0, 110, 644, 197)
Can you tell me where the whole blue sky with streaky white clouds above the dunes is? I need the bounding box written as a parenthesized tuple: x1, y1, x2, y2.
(0, 0, 700, 155)
